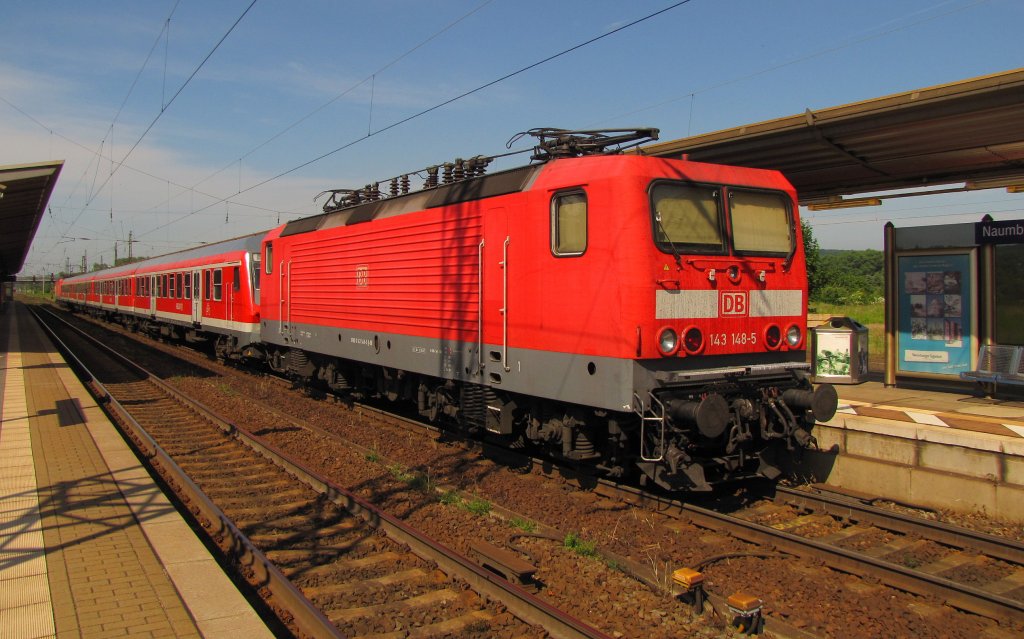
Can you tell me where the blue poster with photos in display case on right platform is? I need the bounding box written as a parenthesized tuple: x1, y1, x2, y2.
(896, 253, 974, 377)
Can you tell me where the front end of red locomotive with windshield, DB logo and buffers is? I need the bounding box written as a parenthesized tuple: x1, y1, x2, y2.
(633, 165, 838, 491)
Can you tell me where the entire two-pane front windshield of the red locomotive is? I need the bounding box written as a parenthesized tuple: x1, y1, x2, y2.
(650, 182, 795, 255)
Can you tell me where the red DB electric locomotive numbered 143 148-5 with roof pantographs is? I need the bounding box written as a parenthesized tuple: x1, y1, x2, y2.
(261, 129, 837, 491)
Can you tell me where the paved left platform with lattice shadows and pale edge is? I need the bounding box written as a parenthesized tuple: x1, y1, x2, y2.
(0, 302, 272, 639)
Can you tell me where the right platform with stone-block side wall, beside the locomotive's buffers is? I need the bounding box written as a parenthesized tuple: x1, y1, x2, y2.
(815, 376, 1024, 522)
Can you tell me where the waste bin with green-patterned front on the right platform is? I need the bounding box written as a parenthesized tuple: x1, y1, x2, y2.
(811, 317, 867, 384)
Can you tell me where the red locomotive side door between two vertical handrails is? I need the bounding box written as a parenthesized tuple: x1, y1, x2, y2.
(479, 208, 512, 376)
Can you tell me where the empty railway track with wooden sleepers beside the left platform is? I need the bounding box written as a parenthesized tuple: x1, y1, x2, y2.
(37, 305, 605, 637)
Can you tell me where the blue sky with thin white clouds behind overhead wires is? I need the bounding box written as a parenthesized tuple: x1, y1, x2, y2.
(0, 0, 1024, 274)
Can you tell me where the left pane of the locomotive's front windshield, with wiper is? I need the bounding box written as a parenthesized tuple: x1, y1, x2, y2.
(650, 182, 725, 255)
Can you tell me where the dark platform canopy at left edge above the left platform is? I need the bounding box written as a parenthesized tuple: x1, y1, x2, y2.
(0, 160, 63, 281)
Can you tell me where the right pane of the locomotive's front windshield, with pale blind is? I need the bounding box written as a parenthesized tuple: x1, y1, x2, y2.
(729, 189, 794, 255)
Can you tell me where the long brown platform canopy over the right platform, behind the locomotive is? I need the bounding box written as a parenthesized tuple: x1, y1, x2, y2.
(643, 69, 1024, 204)
